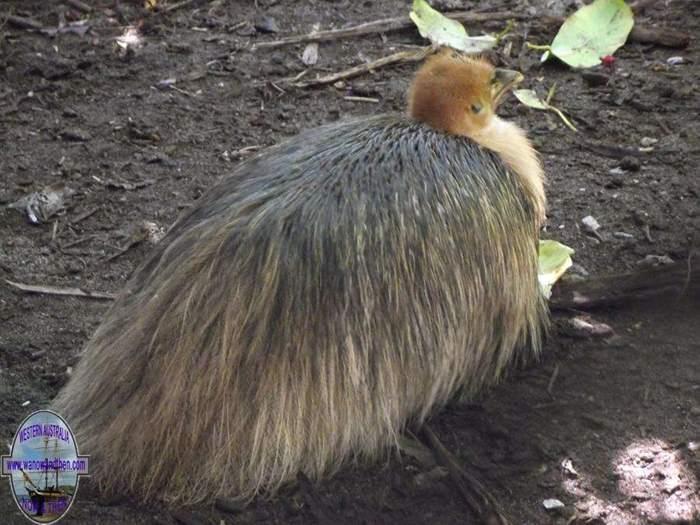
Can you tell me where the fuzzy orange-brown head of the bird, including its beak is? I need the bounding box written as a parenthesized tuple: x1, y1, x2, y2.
(408, 49, 523, 138)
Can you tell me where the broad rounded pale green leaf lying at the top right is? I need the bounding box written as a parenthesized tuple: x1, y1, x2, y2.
(551, 0, 634, 67)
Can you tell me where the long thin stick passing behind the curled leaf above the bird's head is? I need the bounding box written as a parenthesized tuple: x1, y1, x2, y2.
(253, 11, 526, 50)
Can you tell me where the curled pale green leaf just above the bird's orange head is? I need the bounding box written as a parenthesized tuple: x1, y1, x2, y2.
(408, 0, 497, 53)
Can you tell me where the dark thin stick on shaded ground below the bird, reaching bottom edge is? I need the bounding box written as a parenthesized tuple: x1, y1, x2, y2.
(418, 423, 509, 525)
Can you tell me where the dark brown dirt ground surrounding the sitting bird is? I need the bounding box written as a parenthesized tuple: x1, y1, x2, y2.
(0, 0, 700, 524)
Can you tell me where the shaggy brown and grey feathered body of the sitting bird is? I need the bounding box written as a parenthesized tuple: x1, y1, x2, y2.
(54, 53, 546, 503)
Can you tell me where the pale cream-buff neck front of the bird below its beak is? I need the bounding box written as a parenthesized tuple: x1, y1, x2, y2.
(472, 116, 547, 226)
